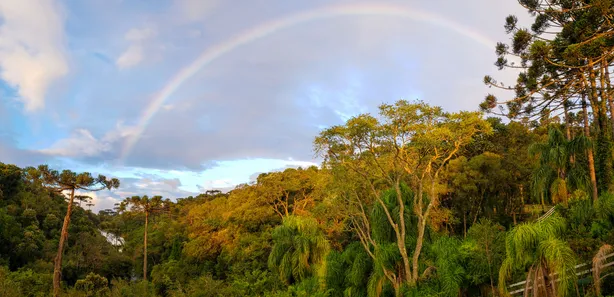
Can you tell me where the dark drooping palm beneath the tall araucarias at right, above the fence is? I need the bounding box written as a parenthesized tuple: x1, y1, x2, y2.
(529, 126, 590, 203)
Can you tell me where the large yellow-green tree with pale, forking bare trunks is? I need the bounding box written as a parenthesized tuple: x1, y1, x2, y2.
(315, 100, 491, 295)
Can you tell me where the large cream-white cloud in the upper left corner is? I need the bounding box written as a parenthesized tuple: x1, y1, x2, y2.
(0, 0, 68, 111)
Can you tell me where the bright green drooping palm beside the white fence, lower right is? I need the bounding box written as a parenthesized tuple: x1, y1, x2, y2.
(499, 213, 576, 296)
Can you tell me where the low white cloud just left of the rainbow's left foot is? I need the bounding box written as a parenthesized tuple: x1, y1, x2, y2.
(39, 123, 136, 157)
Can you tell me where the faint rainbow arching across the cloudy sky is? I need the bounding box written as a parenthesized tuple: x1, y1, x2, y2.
(120, 4, 495, 162)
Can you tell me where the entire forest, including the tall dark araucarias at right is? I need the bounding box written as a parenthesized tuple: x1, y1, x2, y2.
(0, 0, 614, 297)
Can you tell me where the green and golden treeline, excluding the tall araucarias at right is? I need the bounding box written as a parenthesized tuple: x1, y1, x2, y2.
(0, 107, 614, 296)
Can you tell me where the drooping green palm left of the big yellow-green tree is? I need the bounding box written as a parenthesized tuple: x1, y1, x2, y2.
(268, 216, 329, 284)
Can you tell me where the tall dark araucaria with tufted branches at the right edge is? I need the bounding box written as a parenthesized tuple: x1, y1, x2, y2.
(481, 0, 614, 199)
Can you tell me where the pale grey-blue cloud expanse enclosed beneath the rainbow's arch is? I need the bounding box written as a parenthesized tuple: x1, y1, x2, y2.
(124, 11, 483, 166)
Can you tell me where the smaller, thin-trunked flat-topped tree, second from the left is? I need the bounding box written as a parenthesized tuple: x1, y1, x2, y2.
(119, 195, 170, 281)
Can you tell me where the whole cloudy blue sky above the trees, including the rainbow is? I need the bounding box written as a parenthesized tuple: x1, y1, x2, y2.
(0, 0, 528, 210)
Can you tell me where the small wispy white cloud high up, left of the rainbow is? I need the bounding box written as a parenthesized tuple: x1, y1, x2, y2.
(115, 26, 157, 69)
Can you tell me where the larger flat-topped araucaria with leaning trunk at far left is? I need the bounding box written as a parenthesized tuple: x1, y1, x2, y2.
(25, 165, 119, 297)
